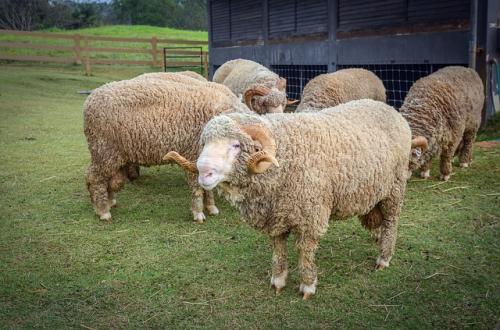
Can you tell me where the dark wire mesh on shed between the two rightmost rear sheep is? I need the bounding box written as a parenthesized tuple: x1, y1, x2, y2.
(337, 64, 465, 109)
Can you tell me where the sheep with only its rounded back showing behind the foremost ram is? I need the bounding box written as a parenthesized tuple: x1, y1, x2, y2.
(295, 69, 386, 112)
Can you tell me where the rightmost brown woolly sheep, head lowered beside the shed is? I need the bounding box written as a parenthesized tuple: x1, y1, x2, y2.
(400, 66, 484, 181)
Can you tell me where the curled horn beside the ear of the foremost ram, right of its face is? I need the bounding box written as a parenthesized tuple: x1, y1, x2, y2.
(240, 124, 279, 174)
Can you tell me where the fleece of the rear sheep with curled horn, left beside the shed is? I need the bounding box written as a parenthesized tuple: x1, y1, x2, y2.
(212, 59, 287, 114)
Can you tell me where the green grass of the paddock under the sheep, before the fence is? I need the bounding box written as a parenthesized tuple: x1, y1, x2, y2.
(0, 65, 500, 329)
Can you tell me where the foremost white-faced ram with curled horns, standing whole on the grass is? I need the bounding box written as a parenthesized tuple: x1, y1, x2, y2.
(164, 99, 411, 299)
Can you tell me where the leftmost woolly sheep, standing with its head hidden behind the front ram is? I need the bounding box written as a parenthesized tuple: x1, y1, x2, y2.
(84, 77, 254, 222)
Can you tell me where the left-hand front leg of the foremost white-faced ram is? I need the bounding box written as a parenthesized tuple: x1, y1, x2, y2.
(271, 233, 289, 294)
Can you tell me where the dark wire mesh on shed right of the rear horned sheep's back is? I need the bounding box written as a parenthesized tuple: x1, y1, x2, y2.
(271, 65, 328, 100)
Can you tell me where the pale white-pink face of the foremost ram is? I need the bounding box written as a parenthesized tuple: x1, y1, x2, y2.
(196, 138, 241, 190)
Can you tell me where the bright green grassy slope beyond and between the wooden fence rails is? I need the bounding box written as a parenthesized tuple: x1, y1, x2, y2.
(0, 25, 208, 60)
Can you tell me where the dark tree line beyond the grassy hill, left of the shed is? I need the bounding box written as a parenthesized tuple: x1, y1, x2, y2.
(0, 0, 207, 31)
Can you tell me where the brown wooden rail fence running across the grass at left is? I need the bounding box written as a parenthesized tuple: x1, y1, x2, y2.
(0, 30, 208, 76)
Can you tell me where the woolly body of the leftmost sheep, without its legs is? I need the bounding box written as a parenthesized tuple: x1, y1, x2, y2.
(84, 79, 235, 165)
